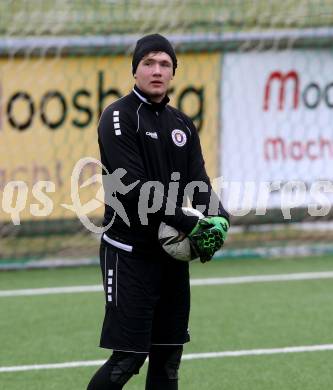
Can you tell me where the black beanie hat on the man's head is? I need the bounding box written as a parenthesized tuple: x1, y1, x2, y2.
(132, 34, 177, 74)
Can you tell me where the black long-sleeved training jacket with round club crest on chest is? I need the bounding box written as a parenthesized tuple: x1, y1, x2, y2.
(98, 86, 228, 252)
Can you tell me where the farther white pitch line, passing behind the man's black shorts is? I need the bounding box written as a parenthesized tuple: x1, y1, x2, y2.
(0, 271, 333, 298)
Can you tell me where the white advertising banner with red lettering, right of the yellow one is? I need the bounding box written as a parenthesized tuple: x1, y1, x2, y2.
(220, 50, 333, 215)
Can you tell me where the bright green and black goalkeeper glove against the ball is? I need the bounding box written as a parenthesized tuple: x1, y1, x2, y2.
(189, 217, 229, 263)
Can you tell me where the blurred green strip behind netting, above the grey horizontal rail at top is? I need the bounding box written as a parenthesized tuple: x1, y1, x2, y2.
(0, 0, 333, 36)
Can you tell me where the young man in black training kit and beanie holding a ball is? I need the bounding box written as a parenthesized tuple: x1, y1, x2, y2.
(88, 34, 229, 390)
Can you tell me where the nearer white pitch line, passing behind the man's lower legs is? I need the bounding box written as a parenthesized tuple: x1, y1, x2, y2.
(0, 344, 333, 373)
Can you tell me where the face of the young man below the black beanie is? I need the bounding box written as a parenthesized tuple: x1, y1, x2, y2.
(134, 51, 173, 102)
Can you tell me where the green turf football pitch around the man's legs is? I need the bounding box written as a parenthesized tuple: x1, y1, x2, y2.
(0, 257, 333, 390)
